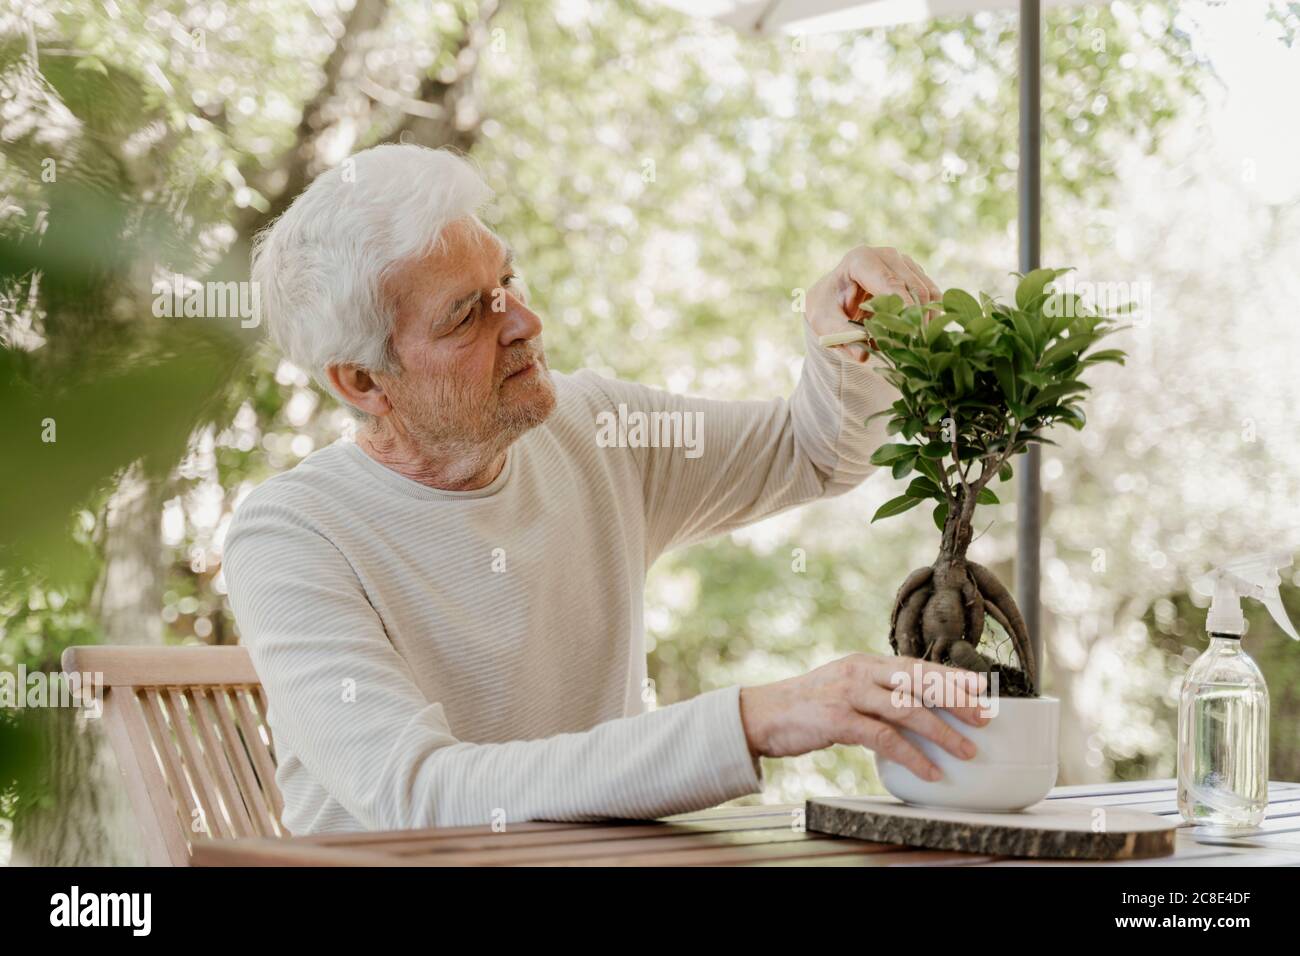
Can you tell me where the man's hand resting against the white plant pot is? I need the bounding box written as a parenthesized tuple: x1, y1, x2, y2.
(740, 654, 989, 780)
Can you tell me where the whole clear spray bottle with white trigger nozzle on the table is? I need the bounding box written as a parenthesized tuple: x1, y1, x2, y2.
(1178, 551, 1300, 831)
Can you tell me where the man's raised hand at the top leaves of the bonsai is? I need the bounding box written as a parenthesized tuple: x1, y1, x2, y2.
(805, 246, 943, 363)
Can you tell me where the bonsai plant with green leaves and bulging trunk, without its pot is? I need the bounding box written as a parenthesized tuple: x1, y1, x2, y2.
(822, 269, 1125, 697)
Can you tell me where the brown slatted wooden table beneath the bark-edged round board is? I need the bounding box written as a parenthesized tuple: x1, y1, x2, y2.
(194, 780, 1300, 868)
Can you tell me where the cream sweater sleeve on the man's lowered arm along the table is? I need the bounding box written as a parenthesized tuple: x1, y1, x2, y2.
(222, 497, 762, 830)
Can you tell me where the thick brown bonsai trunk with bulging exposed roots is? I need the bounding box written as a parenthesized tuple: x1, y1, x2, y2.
(889, 489, 1039, 697)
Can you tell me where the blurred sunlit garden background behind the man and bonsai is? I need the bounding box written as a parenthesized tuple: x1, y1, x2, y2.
(0, 0, 1300, 864)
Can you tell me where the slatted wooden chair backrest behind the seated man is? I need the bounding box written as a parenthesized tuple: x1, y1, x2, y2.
(62, 646, 289, 866)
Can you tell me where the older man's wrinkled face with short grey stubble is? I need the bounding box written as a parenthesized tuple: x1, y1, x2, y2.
(376, 219, 555, 450)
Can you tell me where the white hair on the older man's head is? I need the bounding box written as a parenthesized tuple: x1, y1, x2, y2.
(252, 143, 493, 411)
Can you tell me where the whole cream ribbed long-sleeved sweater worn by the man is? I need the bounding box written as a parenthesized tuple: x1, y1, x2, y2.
(224, 325, 897, 834)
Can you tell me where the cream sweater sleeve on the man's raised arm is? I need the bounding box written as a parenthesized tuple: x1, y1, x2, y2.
(592, 321, 900, 559)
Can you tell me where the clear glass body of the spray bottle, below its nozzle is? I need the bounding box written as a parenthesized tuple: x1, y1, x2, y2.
(1178, 632, 1269, 830)
